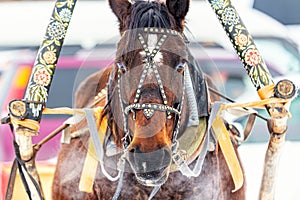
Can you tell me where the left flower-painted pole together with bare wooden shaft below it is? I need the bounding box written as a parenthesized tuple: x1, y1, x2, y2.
(15, 0, 76, 199)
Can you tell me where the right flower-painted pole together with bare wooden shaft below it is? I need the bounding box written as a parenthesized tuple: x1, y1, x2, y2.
(208, 0, 287, 200)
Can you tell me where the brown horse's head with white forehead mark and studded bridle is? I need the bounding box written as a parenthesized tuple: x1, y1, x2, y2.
(108, 0, 189, 186)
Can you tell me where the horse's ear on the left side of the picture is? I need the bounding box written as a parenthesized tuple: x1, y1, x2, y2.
(109, 0, 131, 25)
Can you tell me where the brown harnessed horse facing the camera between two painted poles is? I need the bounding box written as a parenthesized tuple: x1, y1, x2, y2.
(52, 0, 245, 200)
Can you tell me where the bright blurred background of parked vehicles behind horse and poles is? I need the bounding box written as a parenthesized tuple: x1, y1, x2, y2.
(0, 0, 300, 200)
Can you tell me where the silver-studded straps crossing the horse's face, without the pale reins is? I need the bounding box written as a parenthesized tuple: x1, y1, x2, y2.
(117, 28, 186, 150)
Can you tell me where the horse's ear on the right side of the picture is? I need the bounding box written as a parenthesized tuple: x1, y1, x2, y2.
(166, 0, 190, 28)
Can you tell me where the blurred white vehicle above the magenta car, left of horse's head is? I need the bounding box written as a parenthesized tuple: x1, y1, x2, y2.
(0, 1, 118, 50)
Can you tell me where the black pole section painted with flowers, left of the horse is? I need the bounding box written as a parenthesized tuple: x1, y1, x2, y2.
(25, 0, 76, 120)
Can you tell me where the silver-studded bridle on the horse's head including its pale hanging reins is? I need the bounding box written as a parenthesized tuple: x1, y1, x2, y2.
(111, 28, 208, 199)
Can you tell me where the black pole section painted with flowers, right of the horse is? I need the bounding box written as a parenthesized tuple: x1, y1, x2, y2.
(208, 0, 273, 90)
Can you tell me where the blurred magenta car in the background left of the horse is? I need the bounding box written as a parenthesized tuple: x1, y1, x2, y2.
(0, 48, 111, 161)
